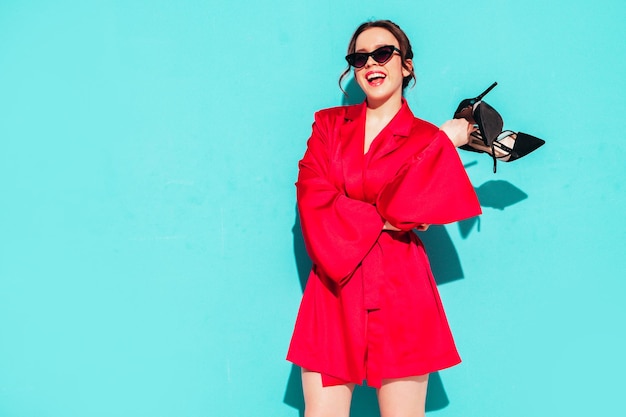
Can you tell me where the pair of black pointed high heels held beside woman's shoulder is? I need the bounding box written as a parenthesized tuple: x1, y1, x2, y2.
(454, 83, 545, 173)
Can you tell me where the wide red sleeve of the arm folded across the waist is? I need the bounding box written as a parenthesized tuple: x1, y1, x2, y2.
(296, 114, 384, 284)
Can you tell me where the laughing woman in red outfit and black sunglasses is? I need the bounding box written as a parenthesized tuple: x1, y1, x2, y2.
(287, 20, 480, 417)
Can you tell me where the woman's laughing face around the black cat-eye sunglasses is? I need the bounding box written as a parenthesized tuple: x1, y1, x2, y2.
(354, 27, 412, 107)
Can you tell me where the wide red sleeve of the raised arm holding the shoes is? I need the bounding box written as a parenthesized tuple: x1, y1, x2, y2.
(376, 130, 481, 230)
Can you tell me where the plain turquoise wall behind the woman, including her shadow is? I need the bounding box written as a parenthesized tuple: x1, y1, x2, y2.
(0, 0, 626, 417)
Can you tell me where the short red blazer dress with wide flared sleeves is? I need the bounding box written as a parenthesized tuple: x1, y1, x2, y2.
(287, 100, 481, 387)
